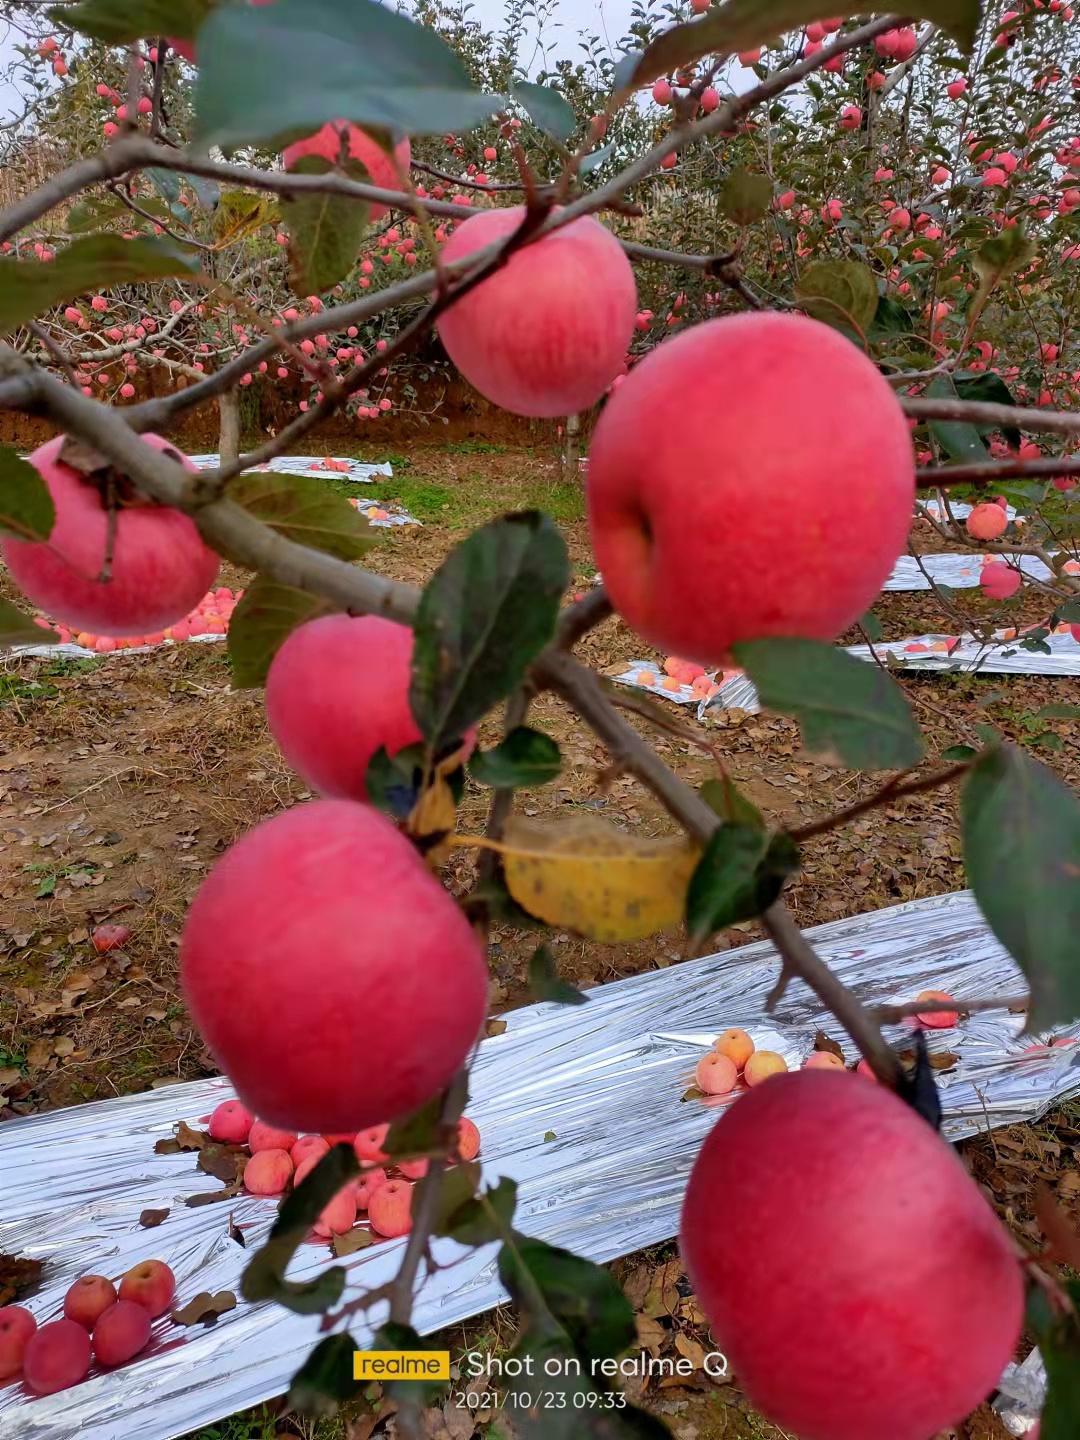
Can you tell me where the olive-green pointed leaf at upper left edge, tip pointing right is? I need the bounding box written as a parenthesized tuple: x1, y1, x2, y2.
(0, 235, 199, 334)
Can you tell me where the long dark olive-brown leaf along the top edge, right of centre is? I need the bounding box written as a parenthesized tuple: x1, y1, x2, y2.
(632, 0, 981, 86)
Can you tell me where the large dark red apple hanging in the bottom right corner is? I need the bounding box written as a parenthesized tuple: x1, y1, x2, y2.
(680, 1070, 1024, 1440)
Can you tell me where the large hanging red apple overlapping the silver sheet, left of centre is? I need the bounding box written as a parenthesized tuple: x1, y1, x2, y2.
(180, 801, 487, 1133)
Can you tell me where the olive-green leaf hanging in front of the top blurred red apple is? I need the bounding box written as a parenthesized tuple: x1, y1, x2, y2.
(281, 156, 372, 297)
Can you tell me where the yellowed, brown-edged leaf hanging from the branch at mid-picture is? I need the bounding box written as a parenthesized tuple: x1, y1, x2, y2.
(503, 815, 698, 945)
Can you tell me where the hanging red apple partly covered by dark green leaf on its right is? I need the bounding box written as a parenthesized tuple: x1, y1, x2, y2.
(266, 615, 443, 801)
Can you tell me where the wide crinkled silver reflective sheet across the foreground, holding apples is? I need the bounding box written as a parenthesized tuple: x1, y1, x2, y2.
(0, 893, 1080, 1440)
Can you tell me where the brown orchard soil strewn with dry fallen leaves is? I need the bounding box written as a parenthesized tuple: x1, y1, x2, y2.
(0, 441, 1080, 1440)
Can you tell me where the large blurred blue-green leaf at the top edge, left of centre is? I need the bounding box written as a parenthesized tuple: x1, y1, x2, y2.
(196, 0, 504, 150)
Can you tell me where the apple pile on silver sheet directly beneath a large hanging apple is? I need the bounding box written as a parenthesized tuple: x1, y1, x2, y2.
(209, 1100, 480, 1240)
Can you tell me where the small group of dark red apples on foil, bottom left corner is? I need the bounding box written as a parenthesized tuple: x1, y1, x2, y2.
(0, 1260, 176, 1395)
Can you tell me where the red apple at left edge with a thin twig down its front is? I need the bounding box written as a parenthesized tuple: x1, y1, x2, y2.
(0, 435, 219, 636)
